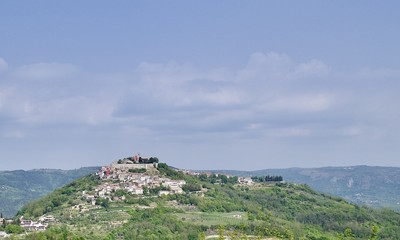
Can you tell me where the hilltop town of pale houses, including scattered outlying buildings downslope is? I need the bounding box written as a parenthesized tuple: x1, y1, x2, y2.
(0, 155, 286, 237)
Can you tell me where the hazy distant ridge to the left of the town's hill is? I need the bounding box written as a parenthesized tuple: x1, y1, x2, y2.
(0, 167, 99, 216)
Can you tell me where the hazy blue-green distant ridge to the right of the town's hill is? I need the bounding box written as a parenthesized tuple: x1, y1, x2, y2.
(211, 166, 400, 211)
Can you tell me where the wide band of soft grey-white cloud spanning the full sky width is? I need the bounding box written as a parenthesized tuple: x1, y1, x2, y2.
(0, 53, 400, 170)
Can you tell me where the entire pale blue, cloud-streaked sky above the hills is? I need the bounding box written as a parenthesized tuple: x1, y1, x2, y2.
(0, 0, 400, 170)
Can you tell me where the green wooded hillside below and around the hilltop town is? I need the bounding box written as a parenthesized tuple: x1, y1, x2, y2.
(7, 164, 400, 240)
